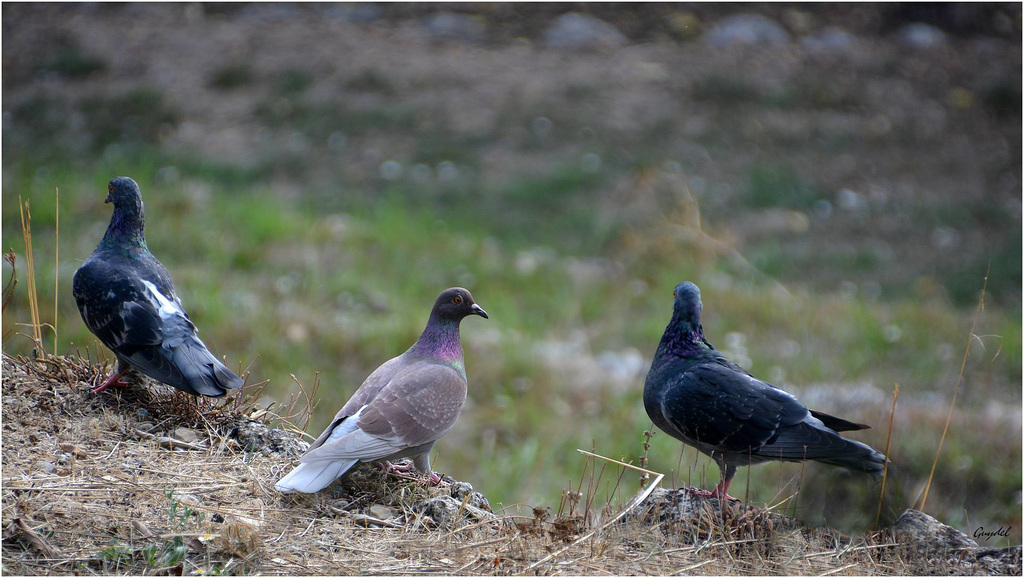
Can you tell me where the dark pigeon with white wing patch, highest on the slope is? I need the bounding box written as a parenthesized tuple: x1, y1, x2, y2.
(73, 176, 242, 398)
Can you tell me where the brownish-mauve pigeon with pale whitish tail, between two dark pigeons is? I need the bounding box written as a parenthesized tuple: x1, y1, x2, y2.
(274, 287, 487, 494)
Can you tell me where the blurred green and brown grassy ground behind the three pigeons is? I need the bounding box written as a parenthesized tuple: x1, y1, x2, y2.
(2, 3, 1022, 546)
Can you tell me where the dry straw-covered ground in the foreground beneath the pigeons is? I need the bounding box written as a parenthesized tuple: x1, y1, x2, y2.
(2, 356, 958, 575)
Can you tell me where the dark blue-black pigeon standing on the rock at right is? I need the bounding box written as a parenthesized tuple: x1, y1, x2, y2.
(643, 282, 886, 499)
